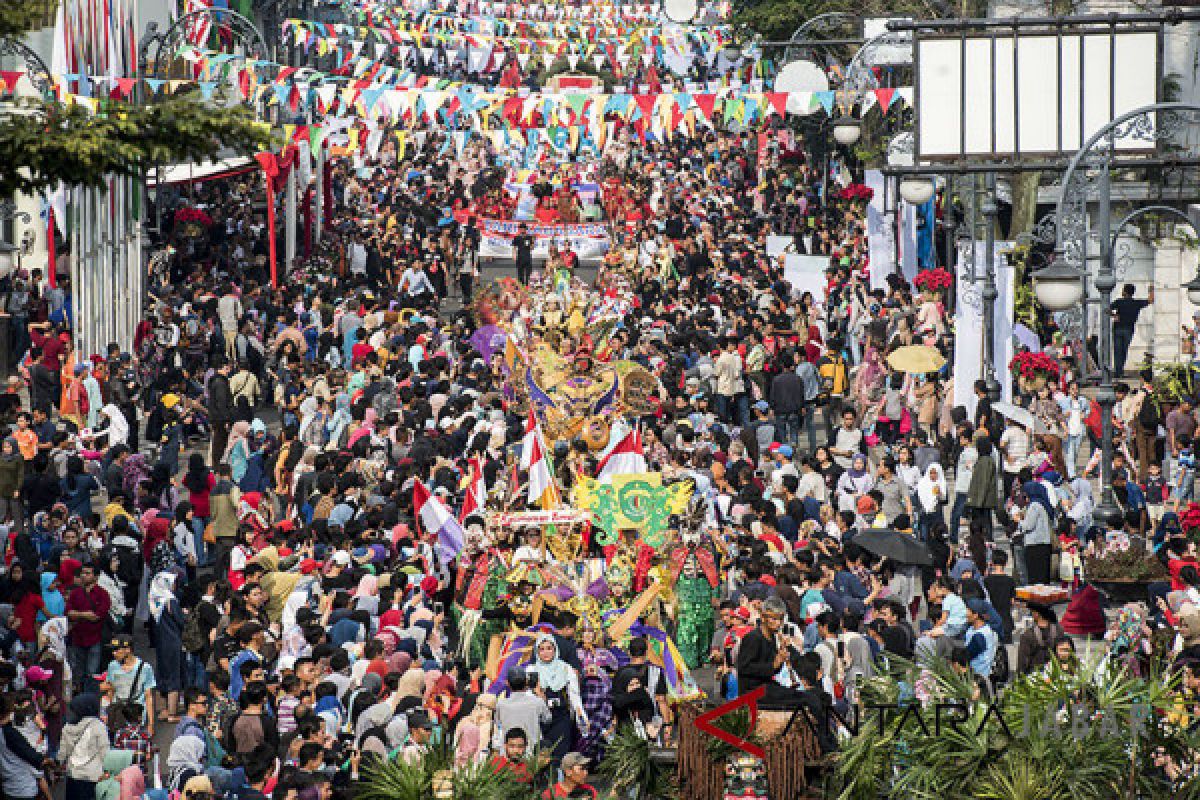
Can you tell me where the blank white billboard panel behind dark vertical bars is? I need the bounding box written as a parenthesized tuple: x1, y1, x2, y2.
(916, 31, 1160, 160)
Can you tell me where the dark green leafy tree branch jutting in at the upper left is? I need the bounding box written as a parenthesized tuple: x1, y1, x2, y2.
(0, 95, 271, 197)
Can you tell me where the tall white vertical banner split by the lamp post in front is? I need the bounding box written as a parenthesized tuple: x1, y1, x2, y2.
(954, 241, 1016, 419)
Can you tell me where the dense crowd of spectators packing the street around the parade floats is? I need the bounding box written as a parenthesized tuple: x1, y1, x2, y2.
(0, 15, 1200, 800)
